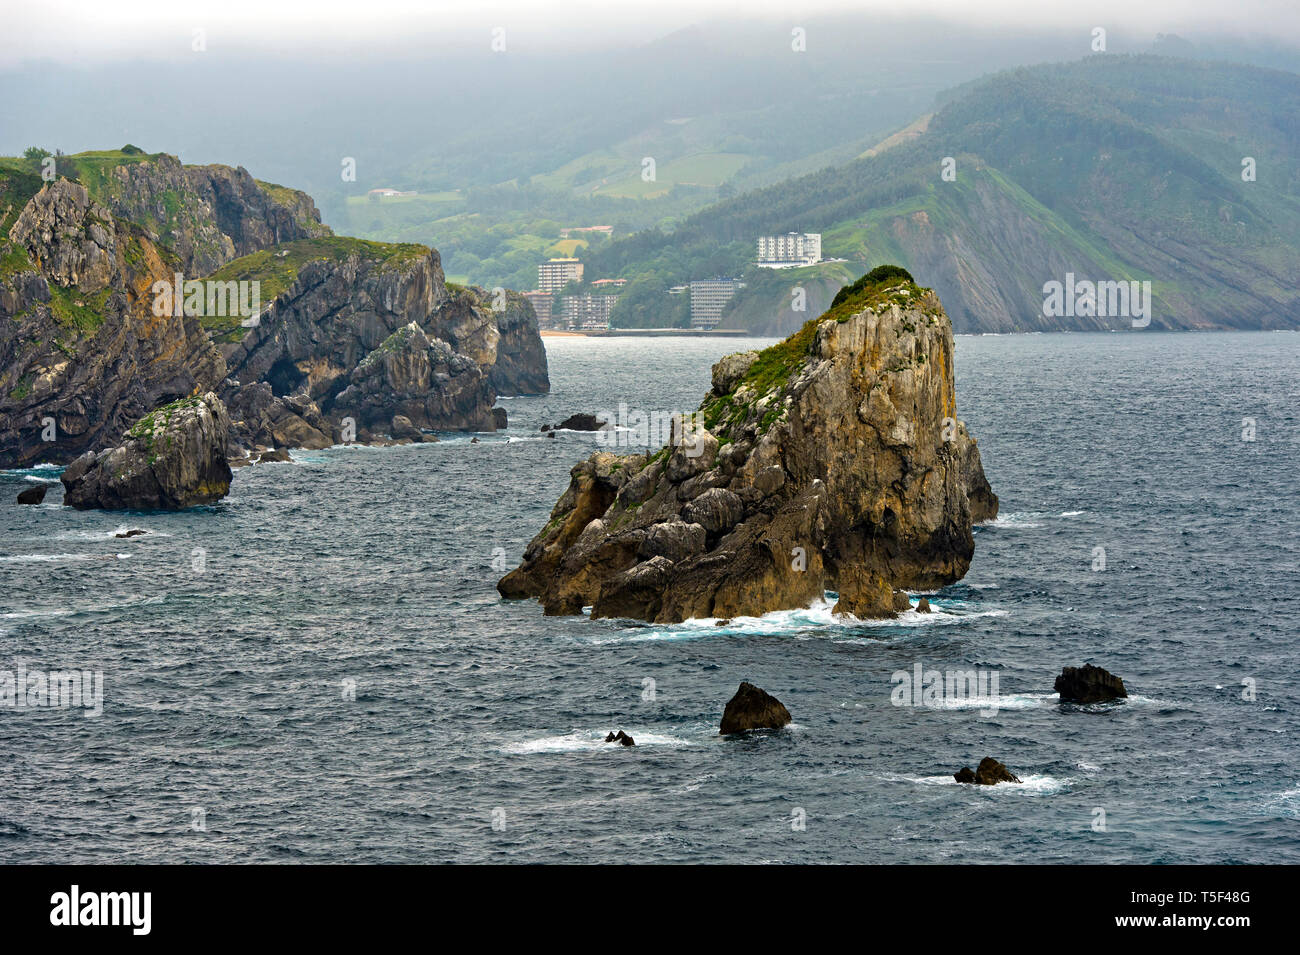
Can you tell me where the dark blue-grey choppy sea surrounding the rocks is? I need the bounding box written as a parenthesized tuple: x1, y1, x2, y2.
(0, 333, 1300, 863)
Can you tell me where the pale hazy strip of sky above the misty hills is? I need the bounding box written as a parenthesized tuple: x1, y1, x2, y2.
(0, 0, 1300, 68)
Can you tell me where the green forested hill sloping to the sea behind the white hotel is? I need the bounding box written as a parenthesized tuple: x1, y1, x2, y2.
(589, 56, 1300, 331)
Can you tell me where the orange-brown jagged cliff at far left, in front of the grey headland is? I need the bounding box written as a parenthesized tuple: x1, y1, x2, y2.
(0, 179, 225, 468)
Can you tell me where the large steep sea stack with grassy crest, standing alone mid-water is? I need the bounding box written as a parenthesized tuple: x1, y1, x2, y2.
(498, 272, 997, 622)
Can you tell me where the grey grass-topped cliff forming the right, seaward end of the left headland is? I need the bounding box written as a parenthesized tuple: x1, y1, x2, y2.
(216, 244, 540, 443)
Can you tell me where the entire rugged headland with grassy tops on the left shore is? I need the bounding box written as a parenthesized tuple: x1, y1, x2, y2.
(0, 147, 550, 468)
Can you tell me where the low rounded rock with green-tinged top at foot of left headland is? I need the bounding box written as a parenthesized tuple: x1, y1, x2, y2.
(62, 391, 230, 511)
